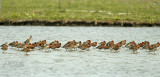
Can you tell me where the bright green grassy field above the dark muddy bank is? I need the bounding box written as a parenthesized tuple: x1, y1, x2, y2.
(0, 0, 160, 23)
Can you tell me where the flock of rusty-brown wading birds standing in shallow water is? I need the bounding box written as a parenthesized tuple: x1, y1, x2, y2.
(1, 36, 160, 55)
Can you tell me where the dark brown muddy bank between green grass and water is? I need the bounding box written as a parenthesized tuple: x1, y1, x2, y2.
(0, 20, 160, 27)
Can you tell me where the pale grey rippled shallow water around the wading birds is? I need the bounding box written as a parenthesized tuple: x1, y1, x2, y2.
(0, 26, 160, 77)
